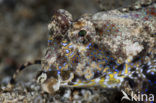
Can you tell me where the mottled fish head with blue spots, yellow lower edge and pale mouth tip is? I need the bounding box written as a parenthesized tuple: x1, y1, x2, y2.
(9, 9, 155, 93)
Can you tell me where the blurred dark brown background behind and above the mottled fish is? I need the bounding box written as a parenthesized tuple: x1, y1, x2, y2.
(0, 0, 138, 82)
